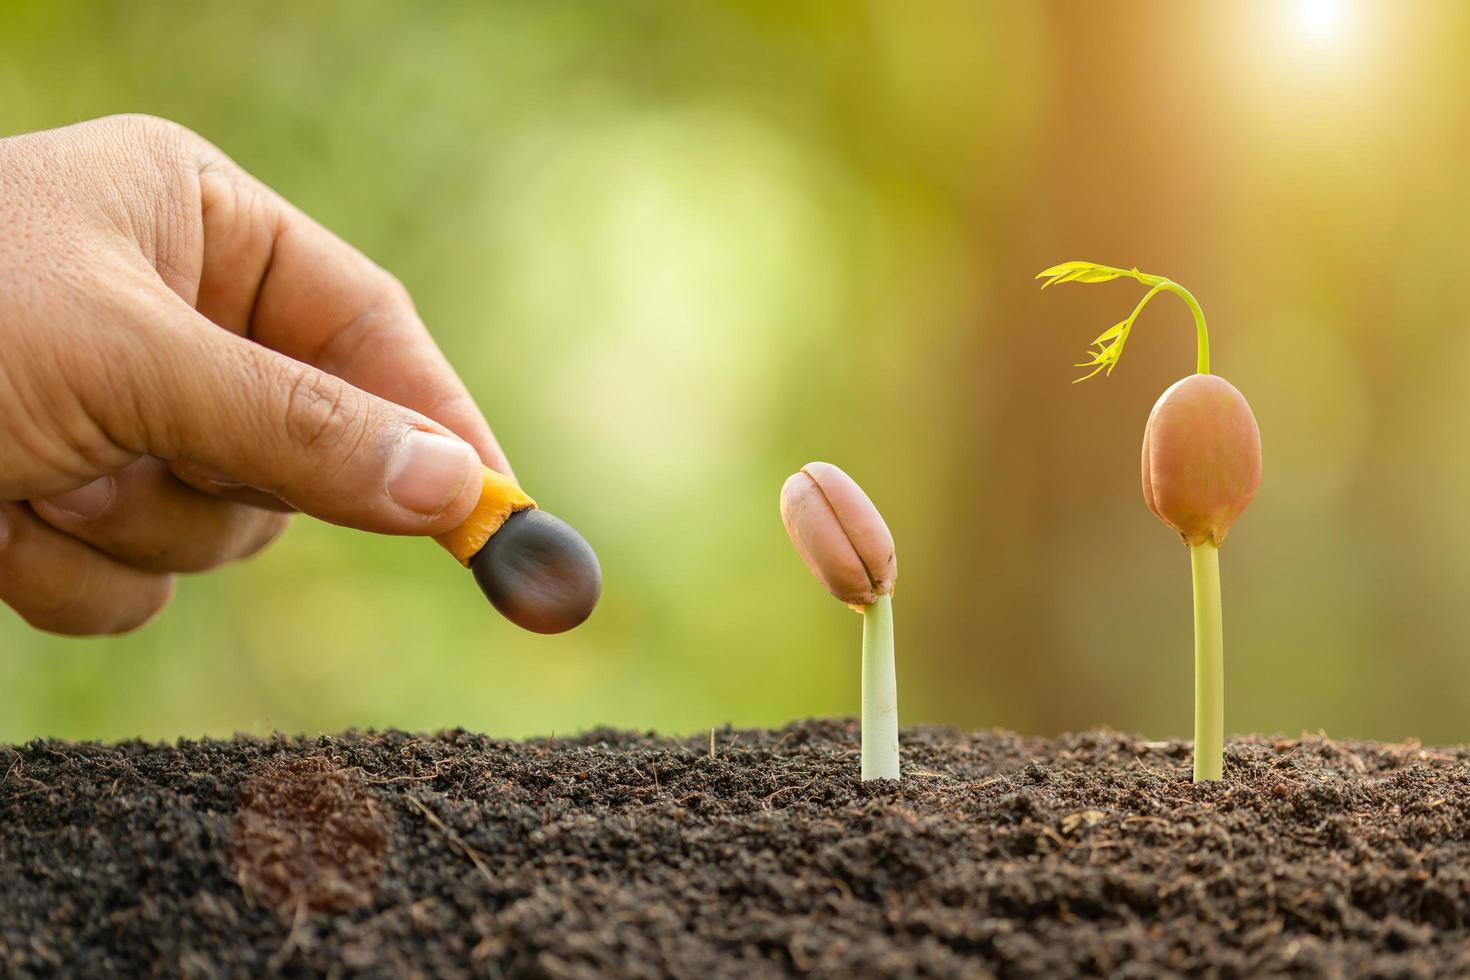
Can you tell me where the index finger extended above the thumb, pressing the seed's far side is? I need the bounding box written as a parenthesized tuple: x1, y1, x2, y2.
(196, 147, 512, 475)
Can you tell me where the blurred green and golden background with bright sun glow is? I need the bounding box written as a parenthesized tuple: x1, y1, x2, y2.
(0, 0, 1470, 742)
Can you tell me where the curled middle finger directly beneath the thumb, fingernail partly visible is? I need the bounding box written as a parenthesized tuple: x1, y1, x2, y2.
(31, 455, 288, 572)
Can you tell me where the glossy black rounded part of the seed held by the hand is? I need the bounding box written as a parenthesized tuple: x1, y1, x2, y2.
(469, 510, 603, 633)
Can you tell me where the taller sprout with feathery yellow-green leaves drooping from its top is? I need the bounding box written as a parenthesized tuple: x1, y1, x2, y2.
(1036, 262, 1261, 783)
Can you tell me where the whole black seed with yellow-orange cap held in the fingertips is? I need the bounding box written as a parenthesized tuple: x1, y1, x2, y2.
(437, 466, 603, 633)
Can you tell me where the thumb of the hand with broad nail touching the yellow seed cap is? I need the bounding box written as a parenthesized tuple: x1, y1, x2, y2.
(129, 310, 482, 535)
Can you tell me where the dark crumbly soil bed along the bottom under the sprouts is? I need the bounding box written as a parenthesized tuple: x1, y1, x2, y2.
(0, 723, 1470, 979)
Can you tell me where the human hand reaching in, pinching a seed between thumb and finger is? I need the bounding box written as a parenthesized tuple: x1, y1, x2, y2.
(0, 116, 510, 635)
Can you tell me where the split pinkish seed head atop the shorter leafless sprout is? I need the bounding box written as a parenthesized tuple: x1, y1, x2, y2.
(781, 463, 898, 605)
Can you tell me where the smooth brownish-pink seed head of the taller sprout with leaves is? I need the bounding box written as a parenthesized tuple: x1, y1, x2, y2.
(1144, 375, 1261, 547)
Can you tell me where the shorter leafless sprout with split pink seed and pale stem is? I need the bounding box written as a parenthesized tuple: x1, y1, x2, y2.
(781, 463, 898, 780)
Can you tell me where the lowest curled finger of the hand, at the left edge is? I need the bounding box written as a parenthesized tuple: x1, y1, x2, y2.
(0, 504, 173, 636)
